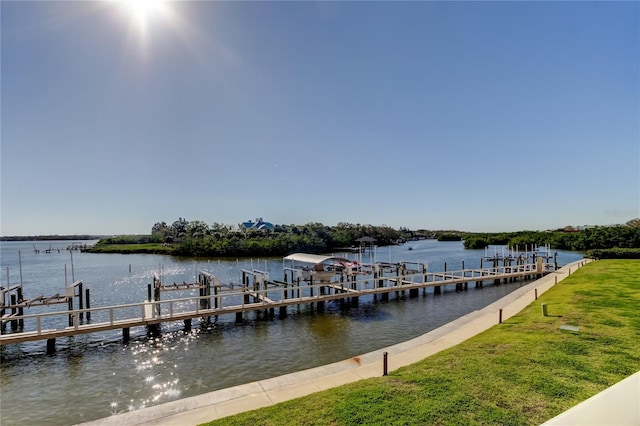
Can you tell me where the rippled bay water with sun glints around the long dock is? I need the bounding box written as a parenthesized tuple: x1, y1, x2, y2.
(0, 240, 582, 425)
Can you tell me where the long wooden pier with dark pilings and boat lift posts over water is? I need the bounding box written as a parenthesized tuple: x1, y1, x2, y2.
(0, 259, 555, 352)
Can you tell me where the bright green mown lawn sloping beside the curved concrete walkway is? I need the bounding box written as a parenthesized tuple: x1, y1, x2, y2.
(201, 260, 640, 425)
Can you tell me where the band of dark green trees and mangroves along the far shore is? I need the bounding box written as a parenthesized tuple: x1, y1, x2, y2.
(2, 218, 640, 259)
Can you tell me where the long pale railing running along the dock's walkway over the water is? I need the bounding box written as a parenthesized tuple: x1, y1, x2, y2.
(0, 263, 551, 344)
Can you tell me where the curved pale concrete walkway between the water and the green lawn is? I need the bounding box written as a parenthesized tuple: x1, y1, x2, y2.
(83, 259, 588, 426)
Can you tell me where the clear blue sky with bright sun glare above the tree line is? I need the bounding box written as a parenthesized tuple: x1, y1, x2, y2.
(0, 1, 640, 235)
